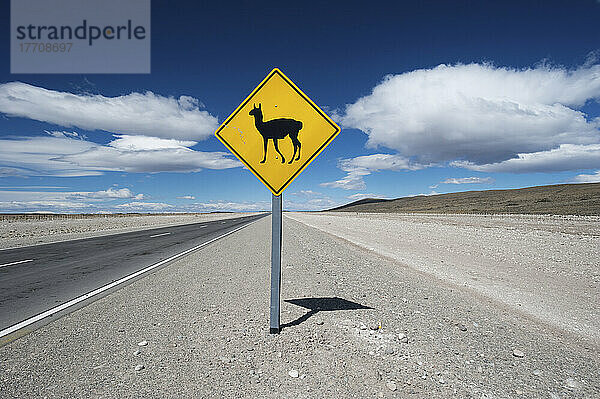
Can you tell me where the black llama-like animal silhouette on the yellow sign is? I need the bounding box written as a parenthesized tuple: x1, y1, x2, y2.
(249, 103, 302, 164)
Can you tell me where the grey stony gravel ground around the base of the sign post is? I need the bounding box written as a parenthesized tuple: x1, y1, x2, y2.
(0, 217, 600, 399)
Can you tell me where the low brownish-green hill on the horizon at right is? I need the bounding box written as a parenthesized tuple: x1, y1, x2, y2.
(330, 183, 600, 216)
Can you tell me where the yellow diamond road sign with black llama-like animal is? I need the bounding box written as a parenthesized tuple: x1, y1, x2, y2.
(215, 68, 340, 195)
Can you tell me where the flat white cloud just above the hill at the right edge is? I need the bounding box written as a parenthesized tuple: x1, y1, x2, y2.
(450, 144, 600, 173)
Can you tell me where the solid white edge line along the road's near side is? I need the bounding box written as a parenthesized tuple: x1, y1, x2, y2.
(0, 218, 262, 338)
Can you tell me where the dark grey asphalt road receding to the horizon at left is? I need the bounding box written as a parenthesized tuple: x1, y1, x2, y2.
(0, 214, 266, 331)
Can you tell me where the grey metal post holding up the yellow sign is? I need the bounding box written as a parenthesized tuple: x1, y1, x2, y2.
(269, 194, 283, 334)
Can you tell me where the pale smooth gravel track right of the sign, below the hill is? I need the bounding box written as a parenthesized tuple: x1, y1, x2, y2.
(289, 213, 600, 347)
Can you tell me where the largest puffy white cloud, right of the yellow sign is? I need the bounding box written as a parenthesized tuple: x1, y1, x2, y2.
(341, 63, 600, 172)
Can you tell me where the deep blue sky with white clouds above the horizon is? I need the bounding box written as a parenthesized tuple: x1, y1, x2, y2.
(0, 0, 600, 212)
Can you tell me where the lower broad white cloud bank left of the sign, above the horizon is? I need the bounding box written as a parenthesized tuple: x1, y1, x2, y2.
(0, 134, 241, 176)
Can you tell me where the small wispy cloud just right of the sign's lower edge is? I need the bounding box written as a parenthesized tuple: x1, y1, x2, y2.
(321, 154, 425, 190)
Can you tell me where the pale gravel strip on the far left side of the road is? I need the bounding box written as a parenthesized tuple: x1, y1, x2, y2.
(0, 213, 252, 249)
